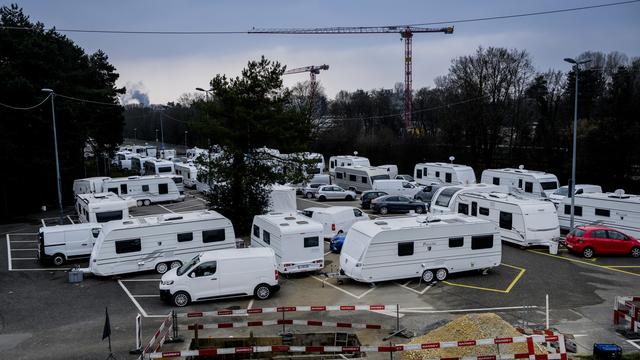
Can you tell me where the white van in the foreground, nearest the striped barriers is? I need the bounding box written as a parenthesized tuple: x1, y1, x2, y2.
(160, 248, 280, 307)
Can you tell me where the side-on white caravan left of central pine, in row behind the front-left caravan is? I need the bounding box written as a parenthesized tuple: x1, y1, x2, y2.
(102, 175, 185, 206)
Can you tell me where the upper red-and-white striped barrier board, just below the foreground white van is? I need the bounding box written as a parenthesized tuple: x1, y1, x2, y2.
(177, 304, 398, 318)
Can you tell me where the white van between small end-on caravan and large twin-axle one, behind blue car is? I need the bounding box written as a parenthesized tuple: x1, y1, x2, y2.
(300, 206, 369, 240)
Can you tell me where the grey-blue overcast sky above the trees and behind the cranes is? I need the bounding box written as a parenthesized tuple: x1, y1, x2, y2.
(10, 0, 640, 103)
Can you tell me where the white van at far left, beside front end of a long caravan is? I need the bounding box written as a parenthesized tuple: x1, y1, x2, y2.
(38, 223, 102, 266)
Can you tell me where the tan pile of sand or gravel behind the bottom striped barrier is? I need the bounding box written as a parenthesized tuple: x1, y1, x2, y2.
(401, 313, 547, 360)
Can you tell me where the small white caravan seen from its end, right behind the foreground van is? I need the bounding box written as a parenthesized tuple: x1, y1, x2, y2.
(251, 213, 324, 273)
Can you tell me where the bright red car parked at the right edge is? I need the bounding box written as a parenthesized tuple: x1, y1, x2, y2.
(565, 225, 640, 258)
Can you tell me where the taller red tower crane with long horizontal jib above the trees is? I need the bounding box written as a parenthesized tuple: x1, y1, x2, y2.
(249, 25, 453, 130)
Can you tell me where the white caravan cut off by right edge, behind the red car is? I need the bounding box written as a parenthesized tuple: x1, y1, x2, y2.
(558, 190, 640, 238)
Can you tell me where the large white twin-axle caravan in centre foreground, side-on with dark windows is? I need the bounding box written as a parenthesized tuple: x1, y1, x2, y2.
(340, 214, 502, 283)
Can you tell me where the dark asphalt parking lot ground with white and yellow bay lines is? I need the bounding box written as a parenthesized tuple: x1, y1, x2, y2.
(0, 193, 640, 359)
